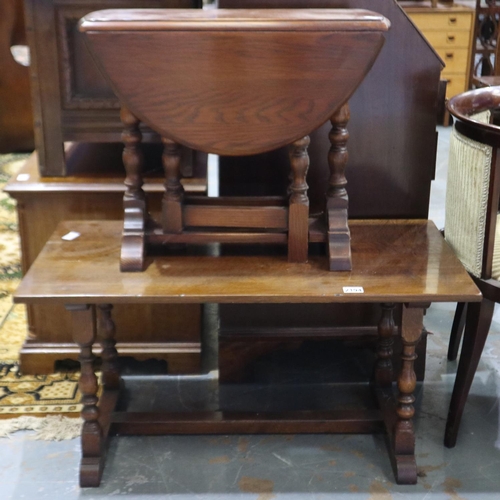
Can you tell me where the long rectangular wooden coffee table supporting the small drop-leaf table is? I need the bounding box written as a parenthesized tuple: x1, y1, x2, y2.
(14, 220, 480, 486)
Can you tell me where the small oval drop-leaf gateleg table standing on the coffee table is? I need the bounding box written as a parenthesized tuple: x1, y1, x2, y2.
(80, 9, 389, 271)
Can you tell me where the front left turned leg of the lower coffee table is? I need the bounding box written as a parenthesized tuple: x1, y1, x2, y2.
(66, 304, 103, 487)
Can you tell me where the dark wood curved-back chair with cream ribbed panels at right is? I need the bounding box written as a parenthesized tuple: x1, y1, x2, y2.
(445, 87, 500, 447)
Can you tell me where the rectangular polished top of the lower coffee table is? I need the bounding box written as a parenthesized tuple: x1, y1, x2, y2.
(14, 220, 481, 304)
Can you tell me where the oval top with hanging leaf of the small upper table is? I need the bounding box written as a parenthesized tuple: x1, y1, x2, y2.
(79, 9, 390, 156)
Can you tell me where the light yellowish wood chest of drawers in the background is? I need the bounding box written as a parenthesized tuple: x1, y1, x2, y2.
(405, 4, 474, 98)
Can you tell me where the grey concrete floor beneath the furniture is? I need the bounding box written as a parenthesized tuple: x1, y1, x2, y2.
(0, 129, 500, 500)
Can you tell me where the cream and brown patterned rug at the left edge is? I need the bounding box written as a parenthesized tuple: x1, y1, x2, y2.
(0, 154, 81, 420)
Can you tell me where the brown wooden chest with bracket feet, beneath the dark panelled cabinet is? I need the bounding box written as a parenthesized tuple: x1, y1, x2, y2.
(5, 144, 206, 373)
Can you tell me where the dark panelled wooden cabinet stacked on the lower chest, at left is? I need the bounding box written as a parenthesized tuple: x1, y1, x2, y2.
(24, 0, 201, 176)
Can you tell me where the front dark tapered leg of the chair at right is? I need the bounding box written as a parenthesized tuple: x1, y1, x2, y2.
(444, 298, 495, 448)
